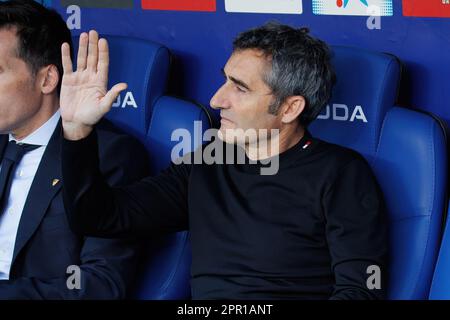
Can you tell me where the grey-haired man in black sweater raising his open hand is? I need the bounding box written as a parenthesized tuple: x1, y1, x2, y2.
(61, 23, 387, 299)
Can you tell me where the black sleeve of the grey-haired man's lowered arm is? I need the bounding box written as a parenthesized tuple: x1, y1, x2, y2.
(323, 157, 387, 300)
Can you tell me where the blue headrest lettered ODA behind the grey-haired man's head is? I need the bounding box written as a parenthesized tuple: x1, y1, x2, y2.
(310, 46, 400, 159)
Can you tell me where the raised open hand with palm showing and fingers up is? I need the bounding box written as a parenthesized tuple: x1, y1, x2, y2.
(60, 31, 127, 140)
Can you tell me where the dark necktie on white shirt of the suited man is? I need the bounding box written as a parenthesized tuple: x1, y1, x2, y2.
(0, 140, 40, 215)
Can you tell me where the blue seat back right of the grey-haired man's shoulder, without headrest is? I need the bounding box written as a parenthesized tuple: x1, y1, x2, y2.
(373, 107, 447, 299)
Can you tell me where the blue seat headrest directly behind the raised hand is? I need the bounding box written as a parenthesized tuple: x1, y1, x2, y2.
(73, 36, 170, 142)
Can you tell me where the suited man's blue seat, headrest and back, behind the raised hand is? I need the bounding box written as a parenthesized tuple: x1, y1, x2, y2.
(73, 36, 207, 299)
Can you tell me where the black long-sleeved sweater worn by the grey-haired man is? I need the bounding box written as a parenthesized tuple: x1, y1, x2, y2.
(62, 131, 387, 299)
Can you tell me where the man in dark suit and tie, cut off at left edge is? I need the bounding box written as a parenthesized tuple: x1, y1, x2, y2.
(0, 0, 147, 299)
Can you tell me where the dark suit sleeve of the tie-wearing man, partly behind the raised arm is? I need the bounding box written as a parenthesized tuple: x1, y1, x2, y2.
(0, 129, 148, 299)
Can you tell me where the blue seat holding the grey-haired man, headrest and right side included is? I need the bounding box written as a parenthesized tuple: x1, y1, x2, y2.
(310, 46, 447, 299)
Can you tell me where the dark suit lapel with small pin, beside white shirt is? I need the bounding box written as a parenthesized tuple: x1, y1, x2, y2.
(12, 121, 62, 263)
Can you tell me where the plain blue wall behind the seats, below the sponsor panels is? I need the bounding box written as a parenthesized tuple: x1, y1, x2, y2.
(47, 0, 450, 123)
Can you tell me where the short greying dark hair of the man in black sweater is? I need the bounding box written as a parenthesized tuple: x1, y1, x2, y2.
(233, 22, 335, 127)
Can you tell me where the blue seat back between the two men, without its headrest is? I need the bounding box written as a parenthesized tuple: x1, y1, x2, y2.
(134, 96, 212, 300)
